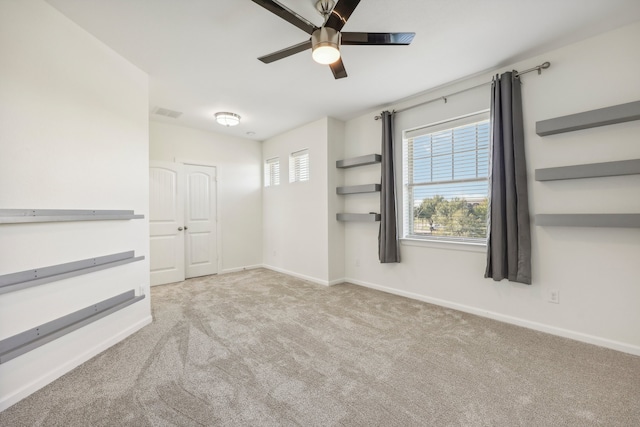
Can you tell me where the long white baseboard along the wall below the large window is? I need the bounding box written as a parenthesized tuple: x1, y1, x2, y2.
(343, 278, 640, 356)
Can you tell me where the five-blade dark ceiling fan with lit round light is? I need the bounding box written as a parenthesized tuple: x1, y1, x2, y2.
(253, 0, 416, 79)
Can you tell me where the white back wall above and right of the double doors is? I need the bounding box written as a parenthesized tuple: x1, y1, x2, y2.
(149, 121, 262, 273)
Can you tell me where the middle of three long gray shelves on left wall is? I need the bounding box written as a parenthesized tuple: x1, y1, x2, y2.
(0, 251, 144, 294)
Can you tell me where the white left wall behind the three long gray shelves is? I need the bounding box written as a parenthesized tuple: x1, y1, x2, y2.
(0, 0, 151, 410)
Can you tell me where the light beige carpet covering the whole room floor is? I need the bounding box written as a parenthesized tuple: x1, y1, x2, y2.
(0, 269, 640, 426)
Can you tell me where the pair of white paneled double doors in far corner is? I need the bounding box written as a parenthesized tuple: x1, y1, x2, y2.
(149, 161, 218, 286)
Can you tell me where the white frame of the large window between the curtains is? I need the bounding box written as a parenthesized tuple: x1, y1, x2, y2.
(400, 109, 492, 247)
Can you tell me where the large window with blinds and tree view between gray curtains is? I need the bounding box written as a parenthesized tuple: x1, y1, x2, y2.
(403, 112, 490, 243)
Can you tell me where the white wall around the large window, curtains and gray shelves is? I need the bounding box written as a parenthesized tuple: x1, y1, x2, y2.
(345, 23, 640, 354)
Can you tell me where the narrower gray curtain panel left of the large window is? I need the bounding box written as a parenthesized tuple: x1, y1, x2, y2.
(378, 111, 400, 263)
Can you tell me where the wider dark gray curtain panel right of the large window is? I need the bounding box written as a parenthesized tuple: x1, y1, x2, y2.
(484, 71, 531, 284)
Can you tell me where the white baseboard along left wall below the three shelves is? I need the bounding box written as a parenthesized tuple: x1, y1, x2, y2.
(0, 316, 153, 412)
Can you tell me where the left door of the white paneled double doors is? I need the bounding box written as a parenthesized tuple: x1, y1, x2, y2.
(149, 161, 184, 286)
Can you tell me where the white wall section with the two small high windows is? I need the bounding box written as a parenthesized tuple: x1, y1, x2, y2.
(262, 118, 335, 284)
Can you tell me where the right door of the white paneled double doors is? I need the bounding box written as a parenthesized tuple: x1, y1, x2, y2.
(184, 165, 218, 277)
